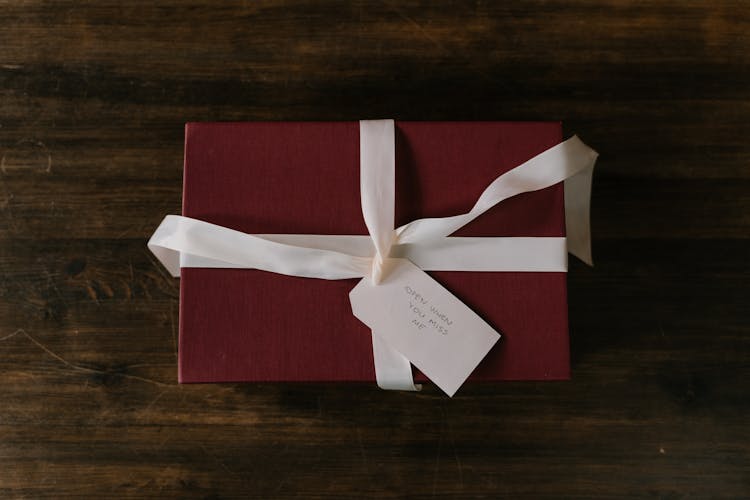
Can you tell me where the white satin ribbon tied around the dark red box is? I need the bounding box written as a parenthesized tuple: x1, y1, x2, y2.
(148, 120, 597, 391)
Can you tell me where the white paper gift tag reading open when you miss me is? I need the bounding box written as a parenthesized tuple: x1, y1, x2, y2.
(349, 259, 500, 396)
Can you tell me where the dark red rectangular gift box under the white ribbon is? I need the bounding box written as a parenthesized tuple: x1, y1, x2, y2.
(179, 121, 570, 383)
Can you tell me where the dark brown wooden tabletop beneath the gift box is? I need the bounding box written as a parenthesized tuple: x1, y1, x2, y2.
(0, 0, 750, 499)
